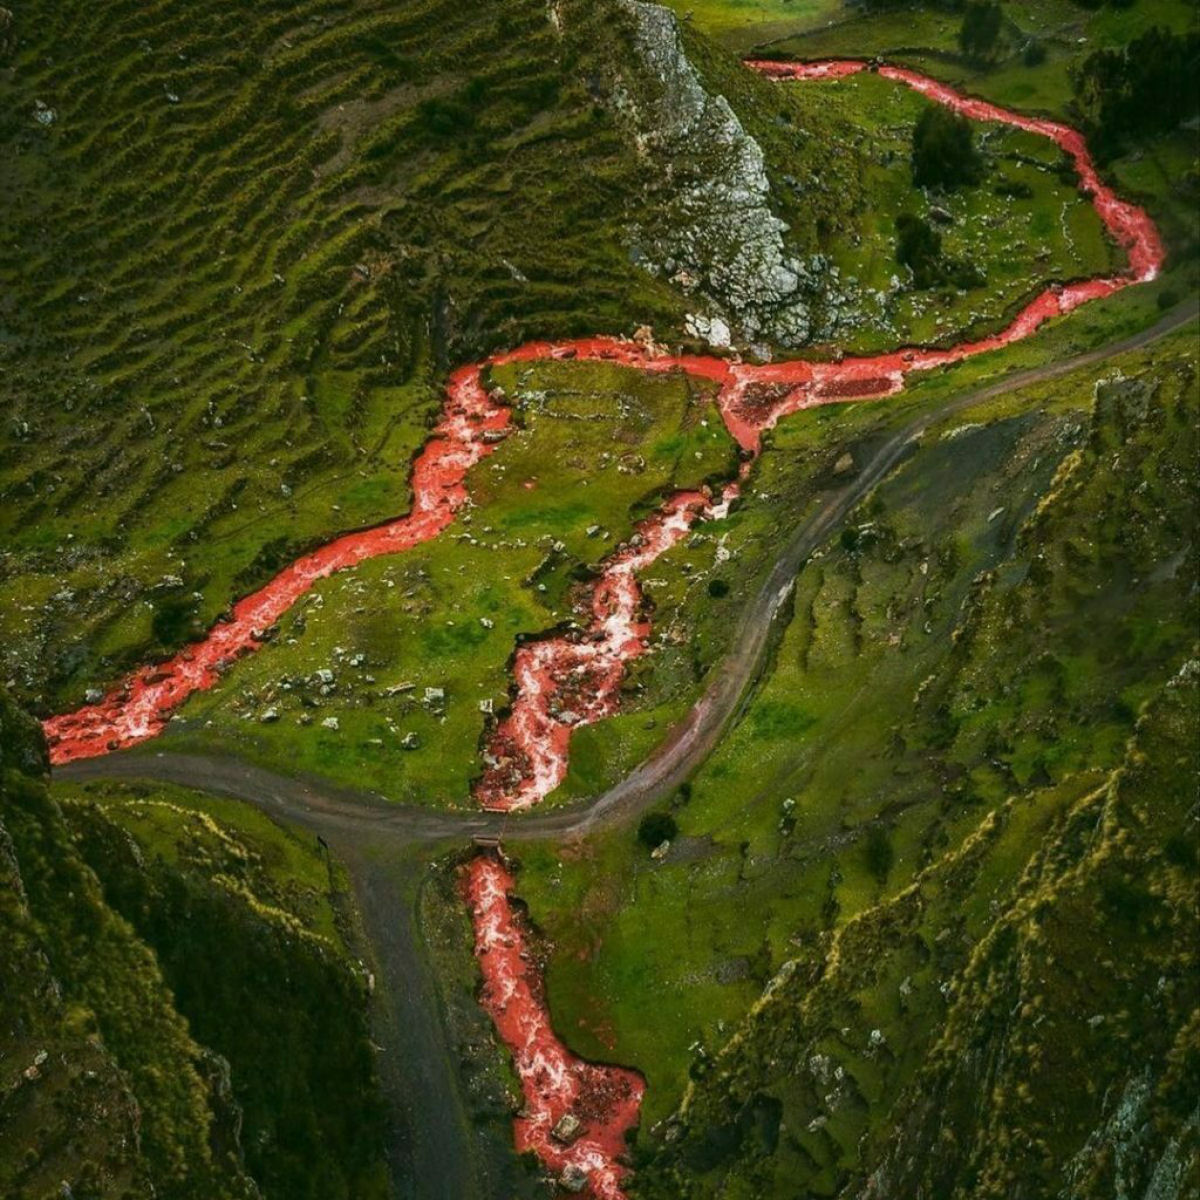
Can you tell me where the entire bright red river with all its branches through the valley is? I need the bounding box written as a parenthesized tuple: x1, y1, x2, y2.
(44, 60, 1163, 1200)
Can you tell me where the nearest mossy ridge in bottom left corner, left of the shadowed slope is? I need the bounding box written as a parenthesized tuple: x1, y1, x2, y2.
(0, 696, 258, 1200)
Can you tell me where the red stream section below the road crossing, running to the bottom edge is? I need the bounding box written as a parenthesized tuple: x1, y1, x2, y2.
(463, 856, 646, 1200)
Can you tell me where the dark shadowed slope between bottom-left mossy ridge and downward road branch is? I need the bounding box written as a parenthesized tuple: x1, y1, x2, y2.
(55, 785, 390, 1200)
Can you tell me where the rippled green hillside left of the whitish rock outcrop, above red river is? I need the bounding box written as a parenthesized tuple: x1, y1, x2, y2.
(0, 0, 696, 704)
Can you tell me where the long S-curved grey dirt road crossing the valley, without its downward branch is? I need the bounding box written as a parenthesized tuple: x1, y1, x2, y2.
(54, 298, 1200, 846)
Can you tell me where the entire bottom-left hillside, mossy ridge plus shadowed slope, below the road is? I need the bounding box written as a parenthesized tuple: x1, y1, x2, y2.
(0, 697, 391, 1200)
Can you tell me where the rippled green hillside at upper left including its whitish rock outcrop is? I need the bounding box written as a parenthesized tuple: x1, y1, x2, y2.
(0, 0, 1111, 729)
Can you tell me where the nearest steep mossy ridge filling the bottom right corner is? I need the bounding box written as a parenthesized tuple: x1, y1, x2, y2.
(858, 660, 1200, 1200)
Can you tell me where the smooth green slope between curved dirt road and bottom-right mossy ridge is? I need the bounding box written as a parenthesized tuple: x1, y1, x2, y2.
(511, 334, 1195, 1142)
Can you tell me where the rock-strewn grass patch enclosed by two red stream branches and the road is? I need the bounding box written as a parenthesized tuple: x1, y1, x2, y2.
(152, 362, 737, 806)
